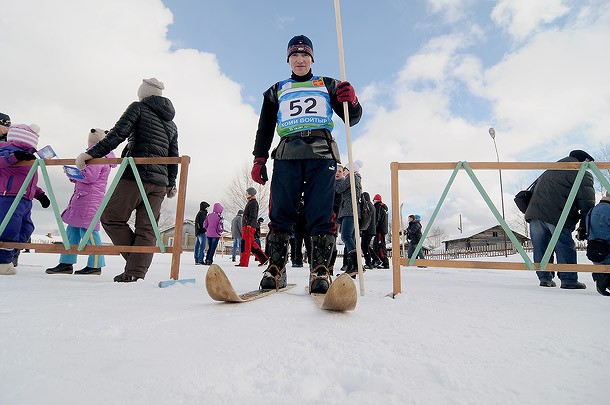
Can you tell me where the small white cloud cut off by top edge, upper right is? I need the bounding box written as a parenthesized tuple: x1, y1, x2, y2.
(491, 0, 569, 41)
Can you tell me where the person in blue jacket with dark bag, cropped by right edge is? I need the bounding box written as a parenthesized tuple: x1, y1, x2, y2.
(586, 192, 610, 296)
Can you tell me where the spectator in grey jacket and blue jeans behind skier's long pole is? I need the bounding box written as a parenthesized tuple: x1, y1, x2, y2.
(335, 160, 362, 275)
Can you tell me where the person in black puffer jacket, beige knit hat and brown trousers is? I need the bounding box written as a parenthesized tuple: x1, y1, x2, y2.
(76, 78, 178, 283)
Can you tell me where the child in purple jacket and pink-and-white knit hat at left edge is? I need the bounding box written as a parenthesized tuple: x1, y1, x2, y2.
(0, 124, 51, 275)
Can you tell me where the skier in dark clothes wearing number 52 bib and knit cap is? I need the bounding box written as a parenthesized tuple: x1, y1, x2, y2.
(252, 35, 362, 293)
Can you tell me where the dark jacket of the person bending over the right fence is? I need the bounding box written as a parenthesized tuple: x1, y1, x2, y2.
(525, 156, 595, 230)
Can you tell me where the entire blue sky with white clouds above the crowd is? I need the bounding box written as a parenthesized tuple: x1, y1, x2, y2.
(0, 0, 610, 233)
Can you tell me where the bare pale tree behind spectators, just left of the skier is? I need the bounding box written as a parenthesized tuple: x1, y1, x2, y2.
(222, 165, 271, 218)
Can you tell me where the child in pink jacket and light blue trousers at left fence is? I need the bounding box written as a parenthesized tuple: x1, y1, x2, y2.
(46, 128, 116, 274)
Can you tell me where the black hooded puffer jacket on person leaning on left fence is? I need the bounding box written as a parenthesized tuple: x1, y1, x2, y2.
(87, 96, 178, 187)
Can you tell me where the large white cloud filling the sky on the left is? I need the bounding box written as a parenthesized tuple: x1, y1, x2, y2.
(0, 0, 257, 230)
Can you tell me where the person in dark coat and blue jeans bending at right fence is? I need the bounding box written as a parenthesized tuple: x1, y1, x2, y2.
(525, 150, 595, 289)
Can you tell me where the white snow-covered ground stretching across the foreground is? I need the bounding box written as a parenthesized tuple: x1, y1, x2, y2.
(0, 248, 610, 405)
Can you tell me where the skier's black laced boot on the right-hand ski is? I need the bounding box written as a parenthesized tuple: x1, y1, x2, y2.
(309, 235, 335, 294)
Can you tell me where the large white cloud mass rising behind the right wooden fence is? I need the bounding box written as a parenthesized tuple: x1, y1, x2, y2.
(346, 1, 610, 234)
